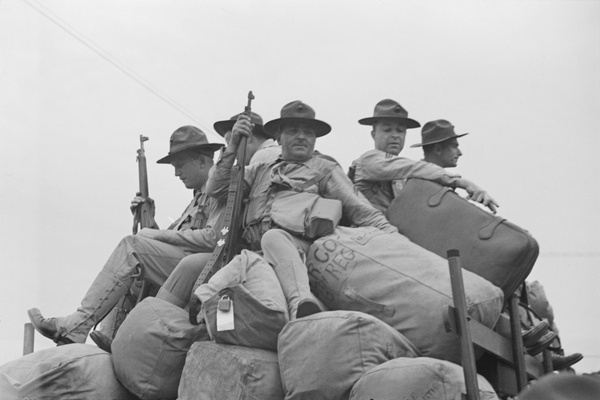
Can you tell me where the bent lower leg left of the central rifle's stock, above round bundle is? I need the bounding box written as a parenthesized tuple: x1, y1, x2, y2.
(156, 253, 212, 308)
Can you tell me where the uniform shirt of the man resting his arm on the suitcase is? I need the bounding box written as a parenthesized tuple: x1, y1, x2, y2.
(349, 149, 460, 213)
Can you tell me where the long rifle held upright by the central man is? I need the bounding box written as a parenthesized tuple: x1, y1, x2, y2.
(189, 91, 254, 325)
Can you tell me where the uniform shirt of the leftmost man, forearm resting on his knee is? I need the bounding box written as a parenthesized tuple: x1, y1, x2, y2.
(139, 185, 224, 253)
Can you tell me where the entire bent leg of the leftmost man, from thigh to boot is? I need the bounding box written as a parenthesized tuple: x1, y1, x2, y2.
(28, 236, 187, 344)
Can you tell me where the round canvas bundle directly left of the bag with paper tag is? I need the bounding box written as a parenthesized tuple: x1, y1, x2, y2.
(112, 297, 209, 400)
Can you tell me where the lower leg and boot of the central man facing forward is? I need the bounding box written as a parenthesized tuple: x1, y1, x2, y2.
(273, 259, 322, 320)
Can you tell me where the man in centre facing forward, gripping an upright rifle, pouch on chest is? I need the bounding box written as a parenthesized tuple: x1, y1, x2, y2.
(207, 101, 397, 319)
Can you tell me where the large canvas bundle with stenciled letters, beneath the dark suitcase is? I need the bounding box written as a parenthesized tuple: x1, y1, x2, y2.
(306, 227, 503, 363)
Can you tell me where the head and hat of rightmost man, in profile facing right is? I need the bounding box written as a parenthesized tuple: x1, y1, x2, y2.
(410, 119, 468, 168)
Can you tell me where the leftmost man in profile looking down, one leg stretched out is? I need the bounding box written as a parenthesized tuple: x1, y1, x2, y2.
(28, 126, 222, 345)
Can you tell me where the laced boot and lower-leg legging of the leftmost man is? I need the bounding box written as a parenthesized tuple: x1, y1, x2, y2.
(28, 270, 133, 344)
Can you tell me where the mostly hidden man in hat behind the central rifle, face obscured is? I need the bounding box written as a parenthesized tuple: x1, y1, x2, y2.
(213, 112, 281, 165)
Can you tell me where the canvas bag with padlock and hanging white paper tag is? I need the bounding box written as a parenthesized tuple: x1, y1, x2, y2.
(194, 250, 290, 351)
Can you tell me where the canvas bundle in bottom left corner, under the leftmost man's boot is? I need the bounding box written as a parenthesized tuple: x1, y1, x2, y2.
(0, 344, 136, 400)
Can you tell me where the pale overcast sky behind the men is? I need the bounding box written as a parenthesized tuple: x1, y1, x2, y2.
(0, 0, 600, 372)
